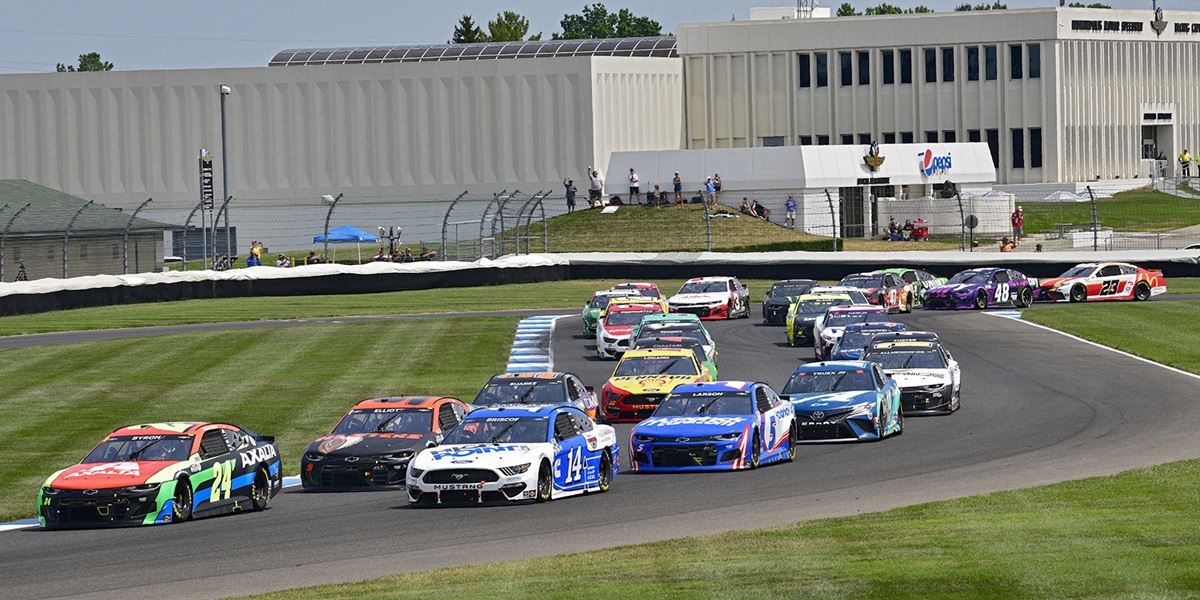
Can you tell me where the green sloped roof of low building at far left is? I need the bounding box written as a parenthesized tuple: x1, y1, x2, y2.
(0, 179, 175, 235)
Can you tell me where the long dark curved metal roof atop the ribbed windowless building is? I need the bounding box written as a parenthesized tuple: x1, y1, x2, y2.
(268, 36, 677, 67)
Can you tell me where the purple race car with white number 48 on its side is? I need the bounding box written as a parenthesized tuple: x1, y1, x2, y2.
(924, 268, 1038, 310)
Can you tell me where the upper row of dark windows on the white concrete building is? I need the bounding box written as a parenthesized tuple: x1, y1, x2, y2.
(799, 43, 1042, 88)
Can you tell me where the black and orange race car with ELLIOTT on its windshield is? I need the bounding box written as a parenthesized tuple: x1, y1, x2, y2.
(300, 396, 469, 491)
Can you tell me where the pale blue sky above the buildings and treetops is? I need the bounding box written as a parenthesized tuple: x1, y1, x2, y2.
(0, 0, 1185, 74)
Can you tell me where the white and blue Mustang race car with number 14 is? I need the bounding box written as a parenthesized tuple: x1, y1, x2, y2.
(407, 406, 620, 506)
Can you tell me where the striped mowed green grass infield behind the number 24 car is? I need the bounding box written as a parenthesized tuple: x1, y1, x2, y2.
(0, 317, 520, 521)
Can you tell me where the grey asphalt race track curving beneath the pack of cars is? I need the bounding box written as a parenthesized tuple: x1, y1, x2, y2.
(0, 305, 1200, 599)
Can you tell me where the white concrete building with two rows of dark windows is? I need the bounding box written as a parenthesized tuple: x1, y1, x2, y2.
(678, 2, 1200, 184)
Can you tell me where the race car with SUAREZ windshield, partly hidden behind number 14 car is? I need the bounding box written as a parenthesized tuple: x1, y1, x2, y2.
(470, 371, 600, 418)
